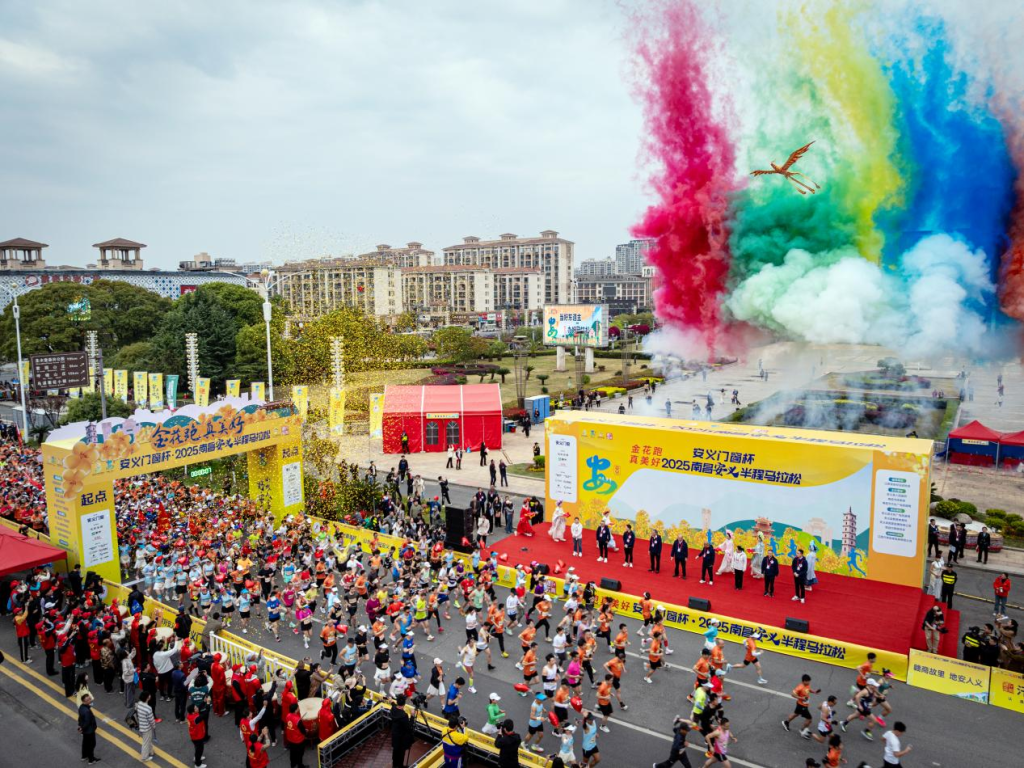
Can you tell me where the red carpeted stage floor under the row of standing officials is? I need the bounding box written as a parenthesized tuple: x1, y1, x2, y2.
(488, 523, 959, 655)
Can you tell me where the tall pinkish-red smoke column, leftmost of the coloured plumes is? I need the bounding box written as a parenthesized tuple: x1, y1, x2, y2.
(633, 0, 735, 351)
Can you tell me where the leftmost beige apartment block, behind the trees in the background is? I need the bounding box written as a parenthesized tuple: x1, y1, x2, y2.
(272, 258, 404, 319)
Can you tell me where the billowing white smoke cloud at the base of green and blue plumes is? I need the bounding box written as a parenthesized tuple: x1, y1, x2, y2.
(727, 234, 998, 358)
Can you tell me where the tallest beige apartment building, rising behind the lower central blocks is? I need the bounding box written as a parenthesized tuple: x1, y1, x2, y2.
(443, 229, 574, 304)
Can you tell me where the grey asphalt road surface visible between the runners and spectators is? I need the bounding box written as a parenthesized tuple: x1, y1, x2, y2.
(0, 544, 1024, 768)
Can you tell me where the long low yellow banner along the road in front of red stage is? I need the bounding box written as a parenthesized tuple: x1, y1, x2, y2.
(322, 521, 905, 679)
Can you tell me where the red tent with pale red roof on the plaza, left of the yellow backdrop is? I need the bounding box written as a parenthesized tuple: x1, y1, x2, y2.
(382, 384, 502, 454)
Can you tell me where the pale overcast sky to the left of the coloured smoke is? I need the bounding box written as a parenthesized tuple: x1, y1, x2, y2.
(0, 0, 644, 267)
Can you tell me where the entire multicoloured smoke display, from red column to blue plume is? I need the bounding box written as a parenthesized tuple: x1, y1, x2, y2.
(636, 3, 1024, 357)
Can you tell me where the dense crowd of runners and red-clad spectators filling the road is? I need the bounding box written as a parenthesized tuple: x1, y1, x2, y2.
(3, 434, 910, 768)
